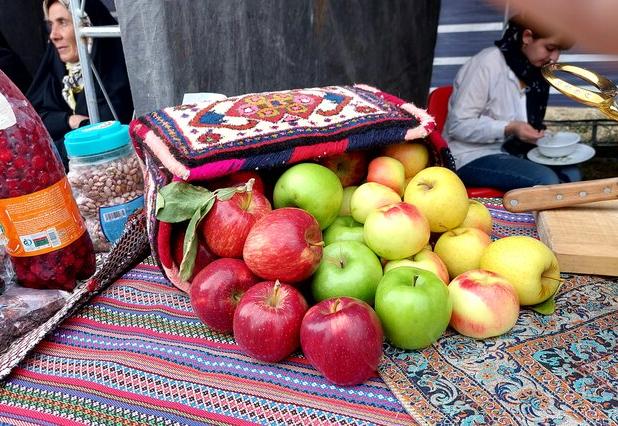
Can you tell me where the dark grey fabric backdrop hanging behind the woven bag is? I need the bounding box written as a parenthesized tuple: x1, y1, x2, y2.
(116, 0, 440, 114)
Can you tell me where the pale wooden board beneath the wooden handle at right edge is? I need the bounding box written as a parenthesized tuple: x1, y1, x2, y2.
(535, 200, 618, 276)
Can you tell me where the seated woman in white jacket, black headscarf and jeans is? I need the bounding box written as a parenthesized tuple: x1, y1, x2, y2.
(444, 16, 581, 191)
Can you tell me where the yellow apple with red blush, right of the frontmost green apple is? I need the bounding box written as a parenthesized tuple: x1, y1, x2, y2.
(448, 269, 519, 339)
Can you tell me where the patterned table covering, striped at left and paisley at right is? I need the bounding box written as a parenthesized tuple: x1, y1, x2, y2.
(0, 200, 618, 425)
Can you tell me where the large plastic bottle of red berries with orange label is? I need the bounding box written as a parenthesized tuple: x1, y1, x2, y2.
(0, 71, 96, 290)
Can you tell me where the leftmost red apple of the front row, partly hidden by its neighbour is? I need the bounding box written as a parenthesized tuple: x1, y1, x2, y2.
(189, 258, 259, 333)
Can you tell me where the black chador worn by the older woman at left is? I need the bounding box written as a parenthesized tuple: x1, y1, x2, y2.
(26, 0, 133, 166)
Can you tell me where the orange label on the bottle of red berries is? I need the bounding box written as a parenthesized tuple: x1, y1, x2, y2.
(0, 177, 86, 257)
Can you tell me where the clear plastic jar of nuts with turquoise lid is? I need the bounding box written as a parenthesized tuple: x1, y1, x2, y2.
(64, 121, 144, 251)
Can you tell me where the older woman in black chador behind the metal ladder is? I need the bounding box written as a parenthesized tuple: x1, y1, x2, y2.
(26, 0, 133, 167)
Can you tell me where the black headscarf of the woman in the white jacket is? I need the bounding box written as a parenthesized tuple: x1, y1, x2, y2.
(494, 20, 549, 130)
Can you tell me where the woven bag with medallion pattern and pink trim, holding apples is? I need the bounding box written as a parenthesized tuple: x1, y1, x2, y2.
(130, 85, 454, 290)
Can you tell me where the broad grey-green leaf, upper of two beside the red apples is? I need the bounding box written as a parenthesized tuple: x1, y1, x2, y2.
(155, 182, 213, 223)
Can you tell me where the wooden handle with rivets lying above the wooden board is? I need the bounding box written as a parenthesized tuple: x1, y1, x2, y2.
(502, 178, 618, 212)
